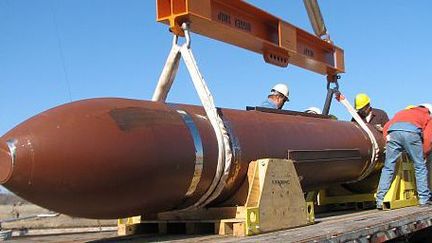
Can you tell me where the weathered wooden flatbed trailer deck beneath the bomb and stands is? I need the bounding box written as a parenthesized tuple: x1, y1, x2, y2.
(7, 206, 432, 242)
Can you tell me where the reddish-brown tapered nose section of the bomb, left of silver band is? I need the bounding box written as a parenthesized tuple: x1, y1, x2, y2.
(0, 99, 202, 219)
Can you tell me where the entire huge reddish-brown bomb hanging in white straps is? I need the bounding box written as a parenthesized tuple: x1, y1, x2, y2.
(0, 98, 383, 218)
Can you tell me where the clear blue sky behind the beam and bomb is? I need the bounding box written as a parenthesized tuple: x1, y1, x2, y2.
(0, 0, 432, 134)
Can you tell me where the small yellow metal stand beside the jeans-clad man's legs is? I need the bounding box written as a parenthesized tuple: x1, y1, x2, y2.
(383, 154, 418, 210)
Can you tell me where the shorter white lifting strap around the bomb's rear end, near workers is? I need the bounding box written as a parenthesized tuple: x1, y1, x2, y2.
(336, 93, 379, 182)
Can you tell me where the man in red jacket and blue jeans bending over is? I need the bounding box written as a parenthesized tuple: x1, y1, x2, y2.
(376, 104, 432, 209)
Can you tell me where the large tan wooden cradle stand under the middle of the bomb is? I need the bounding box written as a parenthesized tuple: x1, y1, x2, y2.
(118, 159, 315, 236)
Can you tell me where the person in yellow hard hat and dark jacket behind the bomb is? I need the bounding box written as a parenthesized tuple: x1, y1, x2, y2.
(352, 93, 389, 132)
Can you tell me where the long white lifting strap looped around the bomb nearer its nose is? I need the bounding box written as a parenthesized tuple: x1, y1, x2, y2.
(152, 24, 232, 209)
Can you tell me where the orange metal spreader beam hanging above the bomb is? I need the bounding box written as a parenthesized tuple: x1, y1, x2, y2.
(157, 0, 345, 75)
